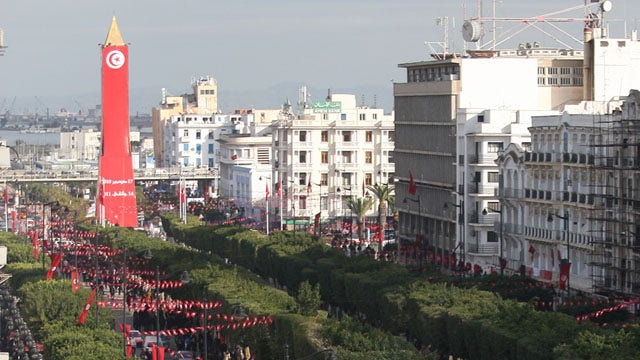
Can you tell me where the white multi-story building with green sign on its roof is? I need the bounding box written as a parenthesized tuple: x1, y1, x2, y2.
(272, 92, 395, 231)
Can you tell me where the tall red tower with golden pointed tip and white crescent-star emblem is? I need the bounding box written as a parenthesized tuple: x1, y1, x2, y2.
(96, 16, 138, 227)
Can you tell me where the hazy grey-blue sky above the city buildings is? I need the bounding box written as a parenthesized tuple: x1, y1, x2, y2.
(0, 0, 640, 113)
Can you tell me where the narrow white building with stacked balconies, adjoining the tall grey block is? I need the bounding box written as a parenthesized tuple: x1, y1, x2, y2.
(456, 109, 558, 269)
